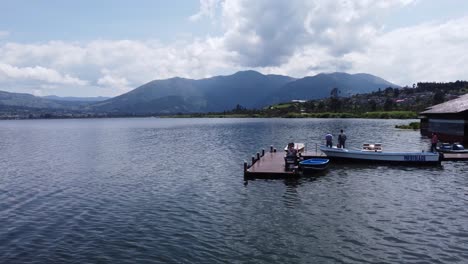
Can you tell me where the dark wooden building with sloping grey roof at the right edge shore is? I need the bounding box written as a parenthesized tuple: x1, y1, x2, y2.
(420, 94, 468, 145)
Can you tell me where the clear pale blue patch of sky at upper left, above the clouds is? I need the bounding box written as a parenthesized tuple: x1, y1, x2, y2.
(0, 0, 216, 43)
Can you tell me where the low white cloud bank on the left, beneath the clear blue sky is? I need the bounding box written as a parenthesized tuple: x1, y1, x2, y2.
(0, 38, 233, 95)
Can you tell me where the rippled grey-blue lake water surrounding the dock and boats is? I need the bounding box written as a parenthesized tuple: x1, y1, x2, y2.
(0, 118, 468, 263)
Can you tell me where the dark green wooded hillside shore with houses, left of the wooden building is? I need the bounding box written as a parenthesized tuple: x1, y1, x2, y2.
(189, 81, 468, 120)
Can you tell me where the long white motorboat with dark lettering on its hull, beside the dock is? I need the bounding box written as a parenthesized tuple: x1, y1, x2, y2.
(320, 144, 440, 164)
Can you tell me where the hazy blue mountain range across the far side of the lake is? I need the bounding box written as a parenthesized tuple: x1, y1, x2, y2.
(0, 71, 399, 114)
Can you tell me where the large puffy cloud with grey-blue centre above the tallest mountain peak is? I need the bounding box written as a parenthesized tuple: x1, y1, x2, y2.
(218, 0, 412, 67)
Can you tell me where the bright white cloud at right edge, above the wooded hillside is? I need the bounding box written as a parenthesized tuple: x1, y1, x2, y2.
(346, 16, 468, 85)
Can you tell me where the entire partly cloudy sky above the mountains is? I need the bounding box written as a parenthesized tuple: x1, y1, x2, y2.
(0, 0, 468, 96)
